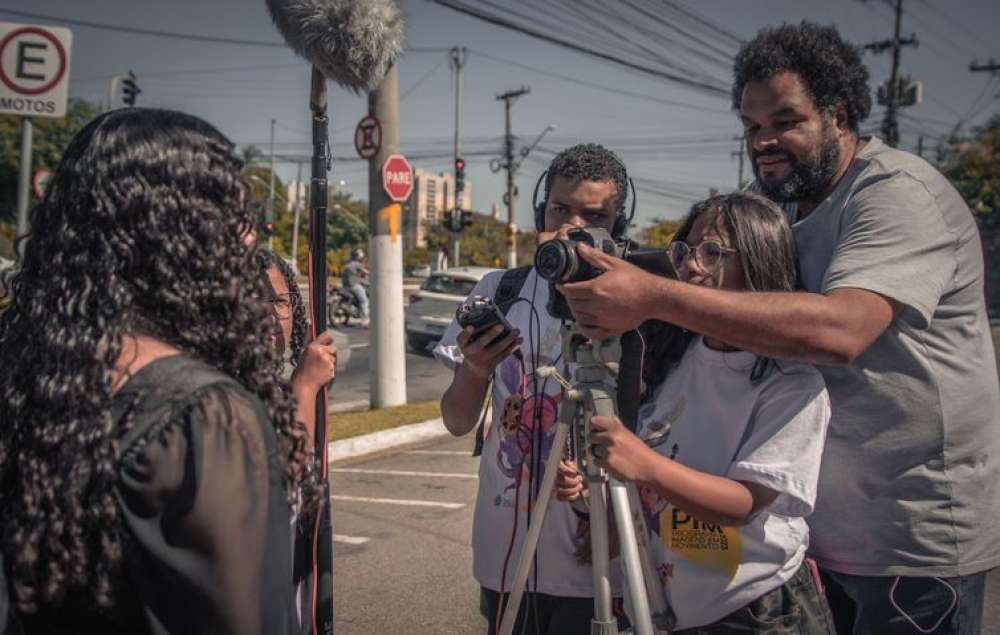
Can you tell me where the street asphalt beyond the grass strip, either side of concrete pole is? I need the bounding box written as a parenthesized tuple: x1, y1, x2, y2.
(331, 325, 451, 407)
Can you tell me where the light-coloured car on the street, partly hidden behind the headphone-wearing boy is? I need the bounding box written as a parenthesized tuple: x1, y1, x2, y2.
(406, 267, 496, 352)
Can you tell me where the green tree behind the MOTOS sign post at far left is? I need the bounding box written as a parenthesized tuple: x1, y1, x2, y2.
(0, 99, 101, 224)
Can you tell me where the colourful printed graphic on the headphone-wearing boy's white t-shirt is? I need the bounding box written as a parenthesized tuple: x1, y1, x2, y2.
(491, 356, 562, 507)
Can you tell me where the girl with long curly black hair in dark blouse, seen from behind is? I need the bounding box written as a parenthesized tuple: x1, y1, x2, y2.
(0, 108, 315, 634)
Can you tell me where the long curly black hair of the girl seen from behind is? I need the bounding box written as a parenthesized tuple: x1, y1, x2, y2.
(0, 108, 315, 614)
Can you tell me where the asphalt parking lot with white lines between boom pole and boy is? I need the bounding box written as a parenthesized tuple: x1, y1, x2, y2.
(330, 437, 485, 635)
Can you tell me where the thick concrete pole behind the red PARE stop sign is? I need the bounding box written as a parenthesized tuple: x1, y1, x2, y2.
(368, 64, 406, 408)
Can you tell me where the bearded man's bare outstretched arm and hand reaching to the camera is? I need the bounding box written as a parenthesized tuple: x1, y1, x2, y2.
(560, 245, 895, 364)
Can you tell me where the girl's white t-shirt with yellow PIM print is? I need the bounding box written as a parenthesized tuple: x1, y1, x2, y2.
(639, 337, 830, 629)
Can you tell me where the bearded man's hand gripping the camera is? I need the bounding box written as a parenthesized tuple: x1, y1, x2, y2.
(558, 245, 659, 340)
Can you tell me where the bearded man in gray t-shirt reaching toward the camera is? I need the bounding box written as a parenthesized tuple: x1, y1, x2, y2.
(562, 22, 1000, 634)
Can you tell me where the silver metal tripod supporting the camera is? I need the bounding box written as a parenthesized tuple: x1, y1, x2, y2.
(499, 322, 674, 635)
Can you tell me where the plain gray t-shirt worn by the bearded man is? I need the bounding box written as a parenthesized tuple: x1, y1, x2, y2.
(786, 138, 1000, 576)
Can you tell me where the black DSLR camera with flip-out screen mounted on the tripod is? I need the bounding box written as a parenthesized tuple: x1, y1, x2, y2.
(535, 227, 677, 320)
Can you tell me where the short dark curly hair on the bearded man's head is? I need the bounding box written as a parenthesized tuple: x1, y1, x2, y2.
(732, 21, 872, 133)
